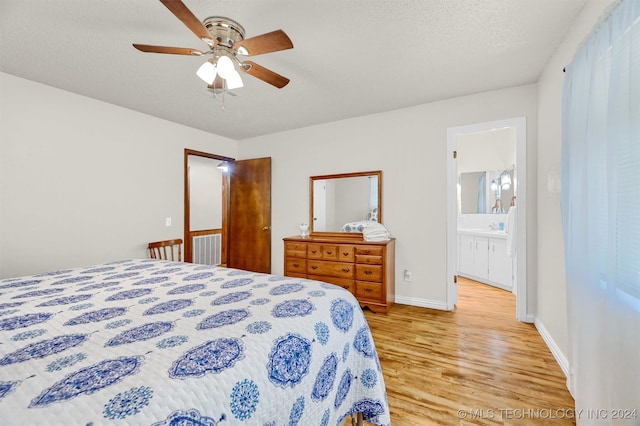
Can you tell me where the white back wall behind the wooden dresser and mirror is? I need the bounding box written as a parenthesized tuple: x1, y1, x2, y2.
(238, 85, 537, 309)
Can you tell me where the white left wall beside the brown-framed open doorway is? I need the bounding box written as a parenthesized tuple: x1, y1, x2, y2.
(0, 73, 237, 278)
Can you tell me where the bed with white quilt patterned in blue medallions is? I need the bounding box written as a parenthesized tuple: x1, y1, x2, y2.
(0, 259, 390, 426)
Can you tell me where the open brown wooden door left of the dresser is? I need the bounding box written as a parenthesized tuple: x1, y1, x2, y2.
(228, 158, 271, 273)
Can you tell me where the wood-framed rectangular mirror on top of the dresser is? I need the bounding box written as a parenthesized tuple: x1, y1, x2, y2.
(309, 170, 382, 235)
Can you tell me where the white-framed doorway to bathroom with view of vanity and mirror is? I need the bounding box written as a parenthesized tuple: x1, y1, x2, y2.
(447, 117, 533, 322)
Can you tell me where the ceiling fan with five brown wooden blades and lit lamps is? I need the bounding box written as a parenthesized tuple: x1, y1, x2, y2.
(133, 0, 293, 90)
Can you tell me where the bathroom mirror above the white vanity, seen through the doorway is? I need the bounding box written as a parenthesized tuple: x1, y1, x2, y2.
(458, 169, 514, 214)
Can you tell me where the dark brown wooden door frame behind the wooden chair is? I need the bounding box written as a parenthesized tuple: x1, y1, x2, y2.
(183, 148, 235, 264)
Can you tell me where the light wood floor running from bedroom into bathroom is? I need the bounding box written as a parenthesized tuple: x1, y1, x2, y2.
(365, 279, 575, 426)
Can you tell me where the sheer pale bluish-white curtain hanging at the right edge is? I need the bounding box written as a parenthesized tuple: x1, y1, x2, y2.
(562, 0, 640, 425)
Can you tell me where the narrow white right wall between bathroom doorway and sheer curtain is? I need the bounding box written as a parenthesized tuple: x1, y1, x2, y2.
(536, 0, 614, 368)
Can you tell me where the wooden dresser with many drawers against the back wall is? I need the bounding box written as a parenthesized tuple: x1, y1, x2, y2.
(284, 234, 395, 314)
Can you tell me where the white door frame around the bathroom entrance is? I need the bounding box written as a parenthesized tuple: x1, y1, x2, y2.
(447, 117, 533, 322)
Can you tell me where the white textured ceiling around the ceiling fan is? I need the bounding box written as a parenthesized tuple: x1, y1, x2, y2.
(0, 0, 586, 140)
